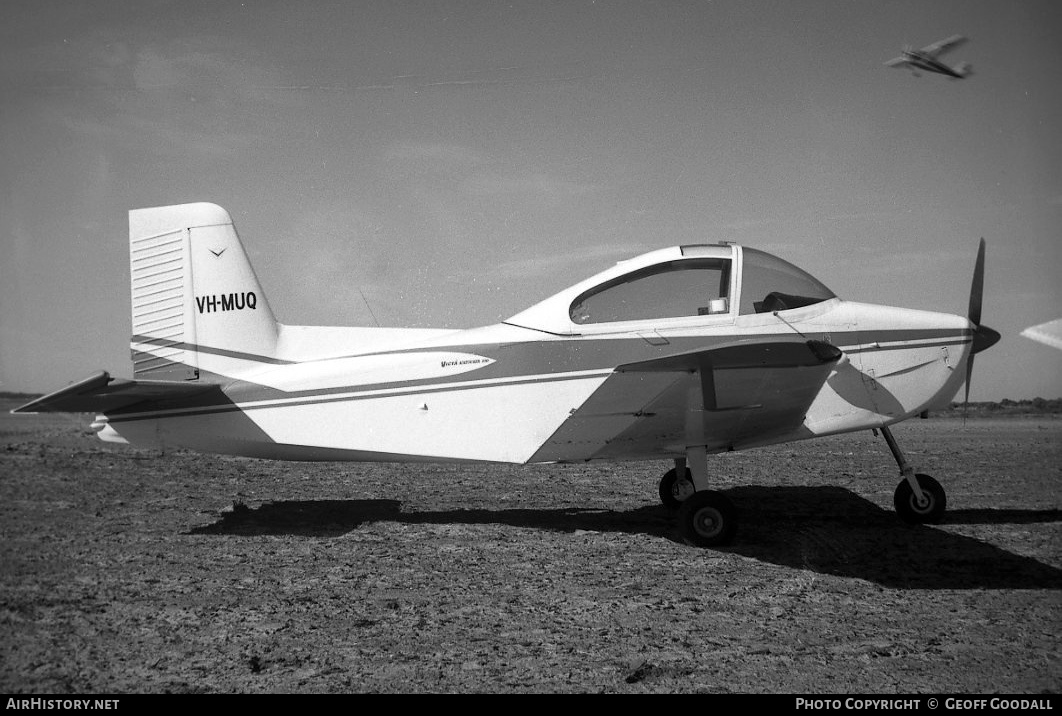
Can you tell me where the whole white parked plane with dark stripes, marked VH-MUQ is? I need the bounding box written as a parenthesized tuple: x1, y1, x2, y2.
(12, 203, 999, 546)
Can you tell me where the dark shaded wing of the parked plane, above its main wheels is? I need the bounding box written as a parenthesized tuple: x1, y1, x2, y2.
(532, 337, 842, 462)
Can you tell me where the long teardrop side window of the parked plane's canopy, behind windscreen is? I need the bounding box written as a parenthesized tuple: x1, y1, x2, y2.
(569, 258, 731, 325)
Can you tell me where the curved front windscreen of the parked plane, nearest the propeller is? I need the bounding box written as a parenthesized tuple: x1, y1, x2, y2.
(739, 249, 836, 316)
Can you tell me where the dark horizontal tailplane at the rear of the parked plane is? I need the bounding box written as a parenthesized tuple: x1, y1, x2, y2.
(12, 371, 220, 413)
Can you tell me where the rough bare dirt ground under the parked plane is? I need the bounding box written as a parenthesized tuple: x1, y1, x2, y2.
(0, 400, 1062, 694)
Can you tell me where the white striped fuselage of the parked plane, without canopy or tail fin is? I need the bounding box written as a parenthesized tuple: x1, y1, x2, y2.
(95, 299, 973, 463)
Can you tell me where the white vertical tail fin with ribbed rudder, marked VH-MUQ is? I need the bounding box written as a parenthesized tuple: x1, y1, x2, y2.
(130, 203, 277, 380)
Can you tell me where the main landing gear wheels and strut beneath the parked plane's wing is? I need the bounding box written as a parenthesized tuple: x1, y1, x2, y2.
(660, 447, 737, 547)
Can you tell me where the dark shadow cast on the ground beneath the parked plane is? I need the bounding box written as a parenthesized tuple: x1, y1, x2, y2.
(191, 487, 1062, 590)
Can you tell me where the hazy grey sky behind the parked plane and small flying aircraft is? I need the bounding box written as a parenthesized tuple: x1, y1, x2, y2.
(0, 0, 1062, 400)
